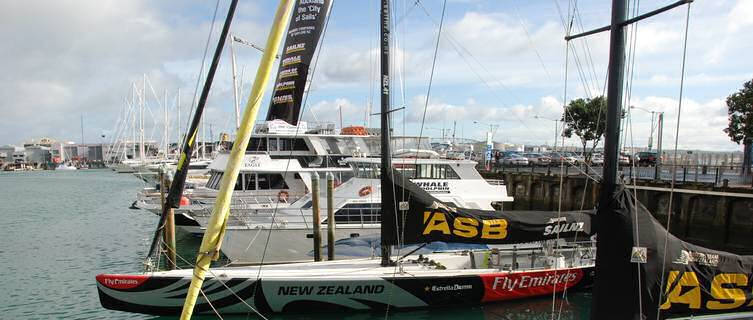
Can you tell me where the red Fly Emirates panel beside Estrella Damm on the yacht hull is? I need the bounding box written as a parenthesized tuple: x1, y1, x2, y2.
(481, 269, 583, 302)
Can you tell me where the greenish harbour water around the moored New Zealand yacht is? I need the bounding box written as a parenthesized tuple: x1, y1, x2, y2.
(0, 170, 591, 320)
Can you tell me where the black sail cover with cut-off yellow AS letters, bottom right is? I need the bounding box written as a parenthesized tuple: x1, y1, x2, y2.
(592, 187, 753, 319)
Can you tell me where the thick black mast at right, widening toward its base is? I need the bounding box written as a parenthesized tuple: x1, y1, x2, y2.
(591, 0, 639, 319)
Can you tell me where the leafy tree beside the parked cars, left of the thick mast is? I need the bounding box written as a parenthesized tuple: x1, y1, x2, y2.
(562, 96, 607, 160)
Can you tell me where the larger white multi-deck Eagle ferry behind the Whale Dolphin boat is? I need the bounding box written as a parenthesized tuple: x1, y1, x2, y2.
(134, 120, 390, 234)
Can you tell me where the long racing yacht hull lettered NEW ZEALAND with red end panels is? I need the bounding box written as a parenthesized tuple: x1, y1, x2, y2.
(97, 266, 593, 315)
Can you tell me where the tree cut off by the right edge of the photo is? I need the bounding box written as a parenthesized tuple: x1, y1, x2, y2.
(724, 80, 753, 175)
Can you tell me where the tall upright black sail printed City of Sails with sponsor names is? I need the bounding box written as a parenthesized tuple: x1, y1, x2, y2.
(267, 0, 331, 125)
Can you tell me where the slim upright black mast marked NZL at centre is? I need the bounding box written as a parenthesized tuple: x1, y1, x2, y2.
(379, 0, 395, 267)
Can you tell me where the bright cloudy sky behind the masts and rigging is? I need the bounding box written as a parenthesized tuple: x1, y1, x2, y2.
(0, 0, 753, 150)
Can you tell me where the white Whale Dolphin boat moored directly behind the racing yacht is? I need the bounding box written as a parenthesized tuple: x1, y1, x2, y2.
(184, 151, 513, 264)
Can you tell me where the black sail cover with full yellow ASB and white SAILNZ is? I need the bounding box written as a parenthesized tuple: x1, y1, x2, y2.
(382, 170, 592, 245)
